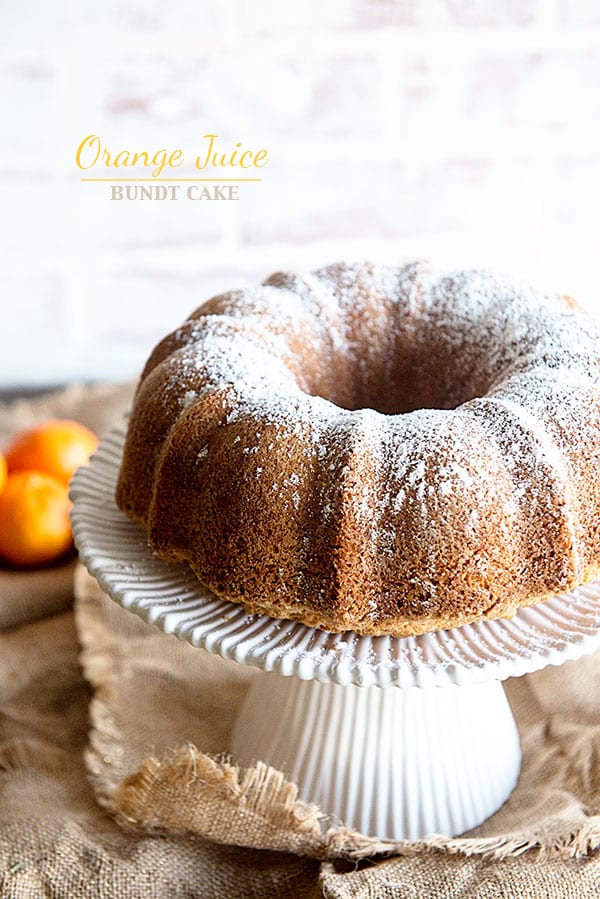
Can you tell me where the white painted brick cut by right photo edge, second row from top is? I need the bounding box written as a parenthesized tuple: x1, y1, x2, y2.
(386, 47, 600, 139)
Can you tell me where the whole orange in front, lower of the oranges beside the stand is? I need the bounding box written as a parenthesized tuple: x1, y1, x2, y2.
(0, 471, 73, 567)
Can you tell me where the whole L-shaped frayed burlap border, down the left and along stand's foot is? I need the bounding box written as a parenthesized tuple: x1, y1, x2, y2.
(75, 569, 600, 861)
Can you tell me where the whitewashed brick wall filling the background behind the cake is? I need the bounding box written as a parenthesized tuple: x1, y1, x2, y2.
(0, 0, 600, 387)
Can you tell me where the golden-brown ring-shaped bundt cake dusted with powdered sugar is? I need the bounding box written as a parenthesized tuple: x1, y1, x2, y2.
(117, 263, 600, 636)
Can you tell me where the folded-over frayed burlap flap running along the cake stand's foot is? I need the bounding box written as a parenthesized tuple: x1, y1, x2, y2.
(109, 745, 600, 860)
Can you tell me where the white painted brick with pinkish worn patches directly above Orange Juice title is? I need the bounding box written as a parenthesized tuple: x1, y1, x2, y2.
(70, 53, 381, 157)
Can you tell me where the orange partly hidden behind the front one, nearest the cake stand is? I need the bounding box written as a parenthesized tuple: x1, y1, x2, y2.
(6, 418, 98, 484)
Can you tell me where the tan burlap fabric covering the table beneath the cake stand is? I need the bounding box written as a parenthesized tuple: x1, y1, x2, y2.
(0, 389, 600, 899)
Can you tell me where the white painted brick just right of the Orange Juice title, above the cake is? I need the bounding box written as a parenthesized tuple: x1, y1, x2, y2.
(240, 158, 551, 244)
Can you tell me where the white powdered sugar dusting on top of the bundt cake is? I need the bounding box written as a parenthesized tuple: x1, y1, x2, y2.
(156, 263, 598, 536)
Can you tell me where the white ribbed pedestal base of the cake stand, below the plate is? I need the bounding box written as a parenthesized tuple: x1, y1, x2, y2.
(231, 673, 521, 840)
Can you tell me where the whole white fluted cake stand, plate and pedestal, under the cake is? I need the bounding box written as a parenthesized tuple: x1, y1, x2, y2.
(71, 425, 600, 840)
